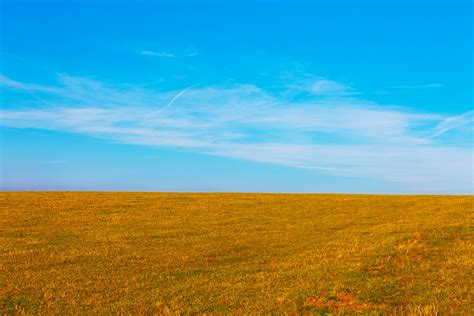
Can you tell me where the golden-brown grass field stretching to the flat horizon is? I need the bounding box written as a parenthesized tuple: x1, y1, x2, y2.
(0, 193, 474, 315)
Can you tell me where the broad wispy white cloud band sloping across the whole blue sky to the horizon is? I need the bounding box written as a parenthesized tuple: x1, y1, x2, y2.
(0, 75, 473, 191)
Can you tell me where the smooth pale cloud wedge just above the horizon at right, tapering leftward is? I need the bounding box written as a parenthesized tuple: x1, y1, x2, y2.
(208, 143, 473, 192)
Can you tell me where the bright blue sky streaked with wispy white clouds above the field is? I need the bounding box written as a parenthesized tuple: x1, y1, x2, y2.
(0, 0, 474, 194)
